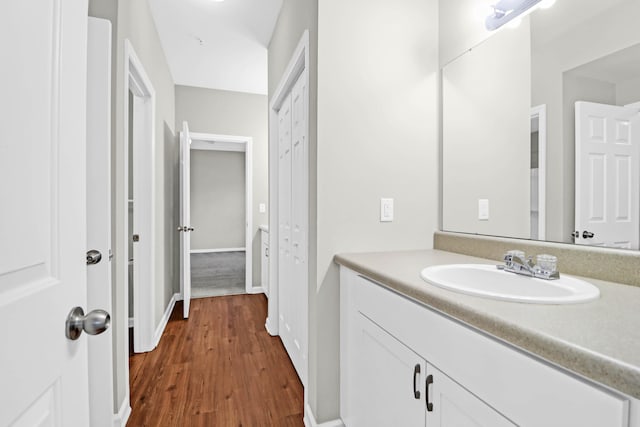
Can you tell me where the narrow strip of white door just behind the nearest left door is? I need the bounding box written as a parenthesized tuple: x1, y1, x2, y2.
(87, 18, 114, 427)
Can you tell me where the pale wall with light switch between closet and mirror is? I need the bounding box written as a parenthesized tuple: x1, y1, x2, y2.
(309, 0, 438, 421)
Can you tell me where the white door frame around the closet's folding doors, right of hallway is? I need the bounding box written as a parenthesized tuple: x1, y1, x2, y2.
(265, 30, 309, 354)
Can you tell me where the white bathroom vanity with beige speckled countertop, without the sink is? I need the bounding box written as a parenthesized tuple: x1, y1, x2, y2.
(336, 250, 640, 427)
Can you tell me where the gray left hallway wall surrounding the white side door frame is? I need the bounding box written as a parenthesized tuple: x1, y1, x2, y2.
(89, 0, 178, 411)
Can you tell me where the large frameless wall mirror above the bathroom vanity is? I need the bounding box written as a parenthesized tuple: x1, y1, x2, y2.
(441, 0, 640, 250)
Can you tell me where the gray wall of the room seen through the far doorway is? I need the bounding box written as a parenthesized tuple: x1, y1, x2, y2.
(191, 150, 246, 250)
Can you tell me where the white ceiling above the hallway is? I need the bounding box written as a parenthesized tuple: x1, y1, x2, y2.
(149, 0, 283, 94)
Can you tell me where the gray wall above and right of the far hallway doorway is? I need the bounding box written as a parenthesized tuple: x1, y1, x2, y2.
(175, 86, 269, 286)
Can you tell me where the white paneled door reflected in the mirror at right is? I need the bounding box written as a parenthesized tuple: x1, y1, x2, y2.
(575, 102, 640, 249)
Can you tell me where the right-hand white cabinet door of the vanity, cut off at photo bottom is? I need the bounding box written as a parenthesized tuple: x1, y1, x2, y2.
(426, 364, 516, 427)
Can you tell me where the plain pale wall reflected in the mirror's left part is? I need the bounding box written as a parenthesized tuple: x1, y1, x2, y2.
(440, 20, 531, 238)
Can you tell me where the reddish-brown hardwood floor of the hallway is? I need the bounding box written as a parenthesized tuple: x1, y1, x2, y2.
(127, 295, 304, 427)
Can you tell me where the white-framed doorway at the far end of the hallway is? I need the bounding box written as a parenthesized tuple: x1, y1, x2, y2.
(178, 126, 255, 318)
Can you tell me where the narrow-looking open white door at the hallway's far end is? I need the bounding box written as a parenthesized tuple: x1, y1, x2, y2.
(178, 122, 193, 319)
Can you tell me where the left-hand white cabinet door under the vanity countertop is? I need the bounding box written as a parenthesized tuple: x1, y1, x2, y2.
(350, 314, 426, 427)
